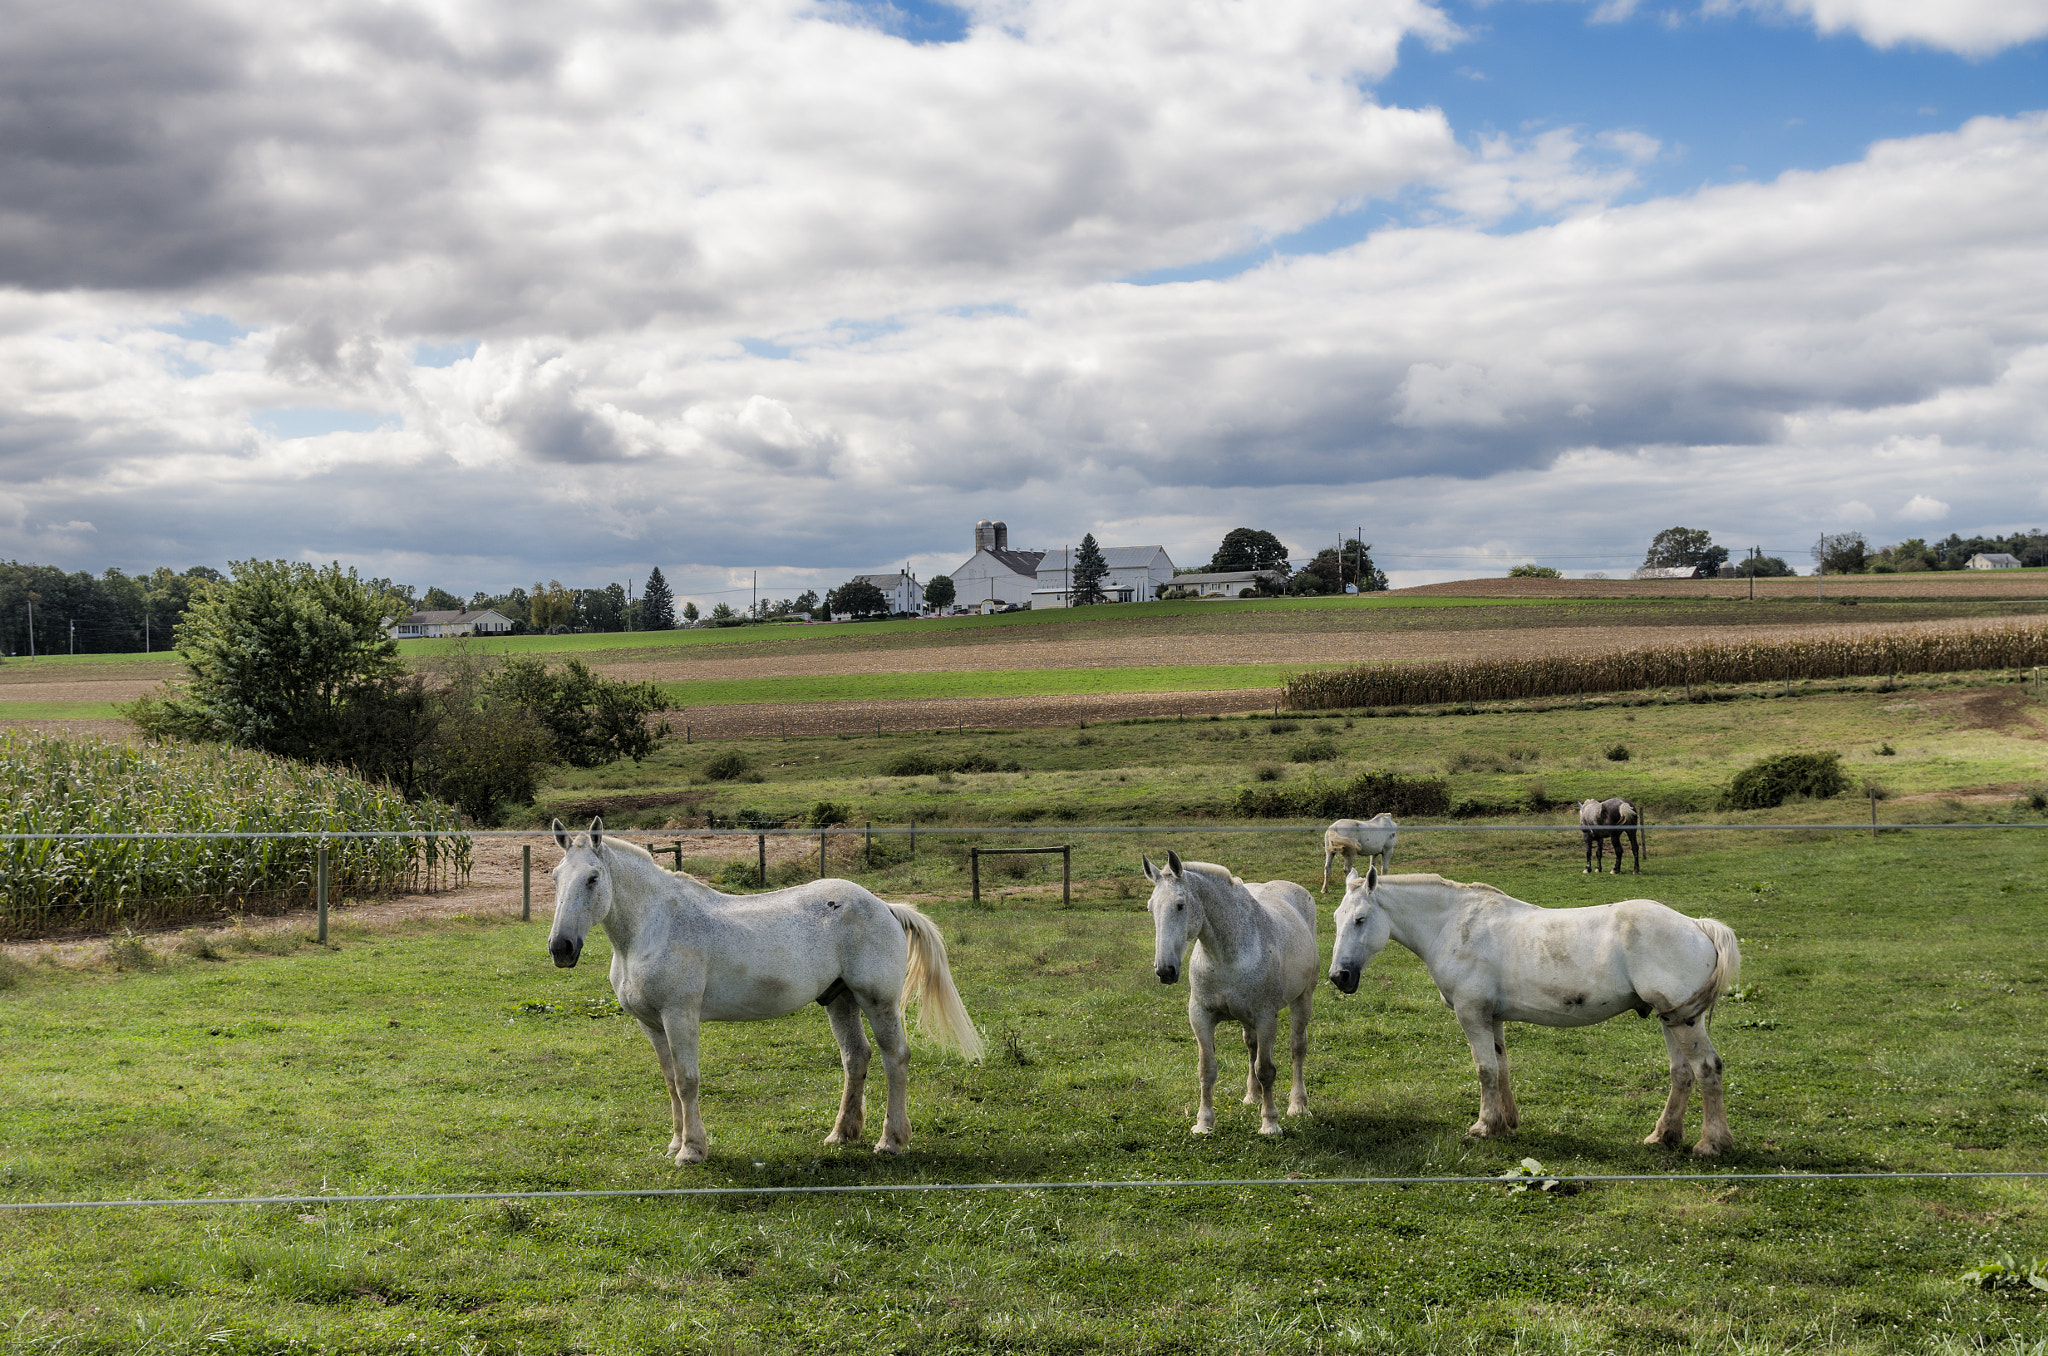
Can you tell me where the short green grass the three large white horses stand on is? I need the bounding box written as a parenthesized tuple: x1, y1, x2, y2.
(0, 832, 2048, 1352)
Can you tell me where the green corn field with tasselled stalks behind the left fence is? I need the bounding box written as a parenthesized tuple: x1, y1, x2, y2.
(0, 729, 469, 936)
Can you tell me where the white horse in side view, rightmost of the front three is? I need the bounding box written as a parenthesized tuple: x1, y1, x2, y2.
(1329, 866, 1743, 1157)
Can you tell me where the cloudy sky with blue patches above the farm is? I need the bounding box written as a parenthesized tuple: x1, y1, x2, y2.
(0, 0, 2048, 602)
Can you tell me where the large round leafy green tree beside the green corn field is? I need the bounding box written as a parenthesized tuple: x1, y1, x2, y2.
(131, 561, 399, 758)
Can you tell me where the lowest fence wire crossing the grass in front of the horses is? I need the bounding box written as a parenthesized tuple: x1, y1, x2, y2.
(0, 1170, 2048, 1211)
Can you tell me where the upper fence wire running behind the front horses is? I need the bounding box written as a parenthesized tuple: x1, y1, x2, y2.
(0, 819, 2048, 842)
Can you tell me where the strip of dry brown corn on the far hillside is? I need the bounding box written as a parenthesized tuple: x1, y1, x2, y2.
(1282, 623, 2048, 711)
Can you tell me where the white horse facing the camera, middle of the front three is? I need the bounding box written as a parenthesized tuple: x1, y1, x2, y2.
(1145, 852, 1321, 1135)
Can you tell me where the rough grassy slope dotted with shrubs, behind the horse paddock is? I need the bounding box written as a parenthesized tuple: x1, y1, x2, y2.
(537, 674, 2048, 825)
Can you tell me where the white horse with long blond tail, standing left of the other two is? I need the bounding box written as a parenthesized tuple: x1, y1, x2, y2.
(547, 819, 981, 1166)
